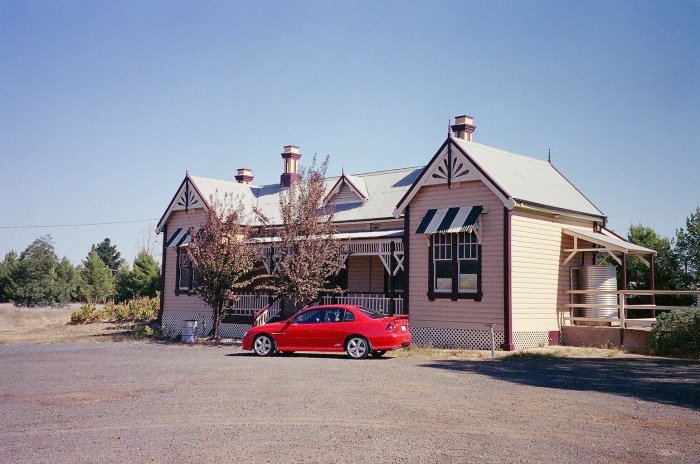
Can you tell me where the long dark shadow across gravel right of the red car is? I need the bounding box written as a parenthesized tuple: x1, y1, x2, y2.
(423, 358, 700, 409)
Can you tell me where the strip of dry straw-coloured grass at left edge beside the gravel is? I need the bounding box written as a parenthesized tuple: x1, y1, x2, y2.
(0, 304, 139, 345)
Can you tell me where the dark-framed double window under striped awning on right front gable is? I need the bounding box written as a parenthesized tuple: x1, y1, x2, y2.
(428, 232, 481, 301)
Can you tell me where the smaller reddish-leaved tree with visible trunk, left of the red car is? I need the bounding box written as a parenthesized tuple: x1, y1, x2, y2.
(187, 195, 258, 340)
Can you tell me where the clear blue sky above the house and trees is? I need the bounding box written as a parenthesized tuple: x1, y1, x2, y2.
(0, 0, 700, 264)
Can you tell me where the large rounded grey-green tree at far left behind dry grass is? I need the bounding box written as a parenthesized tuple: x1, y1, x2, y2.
(10, 235, 58, 306)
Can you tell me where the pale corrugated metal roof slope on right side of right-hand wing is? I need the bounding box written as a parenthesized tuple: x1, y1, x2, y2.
(452, 138, 604, 216)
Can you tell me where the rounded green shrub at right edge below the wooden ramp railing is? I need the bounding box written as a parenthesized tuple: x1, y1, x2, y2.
(649, 308, 700, 358)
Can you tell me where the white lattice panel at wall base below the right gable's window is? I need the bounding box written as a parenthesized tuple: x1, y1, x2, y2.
(411, 327, 505, 350)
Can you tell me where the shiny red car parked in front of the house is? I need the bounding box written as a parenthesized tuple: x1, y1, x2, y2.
(243, 305, 411, 359)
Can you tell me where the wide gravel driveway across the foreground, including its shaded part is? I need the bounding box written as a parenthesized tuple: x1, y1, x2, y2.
(0, 343, 700, 463)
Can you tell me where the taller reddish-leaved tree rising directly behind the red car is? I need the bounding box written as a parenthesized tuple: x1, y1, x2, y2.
(257, 157, 345, 307)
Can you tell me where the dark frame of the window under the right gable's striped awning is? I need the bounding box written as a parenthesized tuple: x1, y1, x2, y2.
(427, 231, 483, 301)
